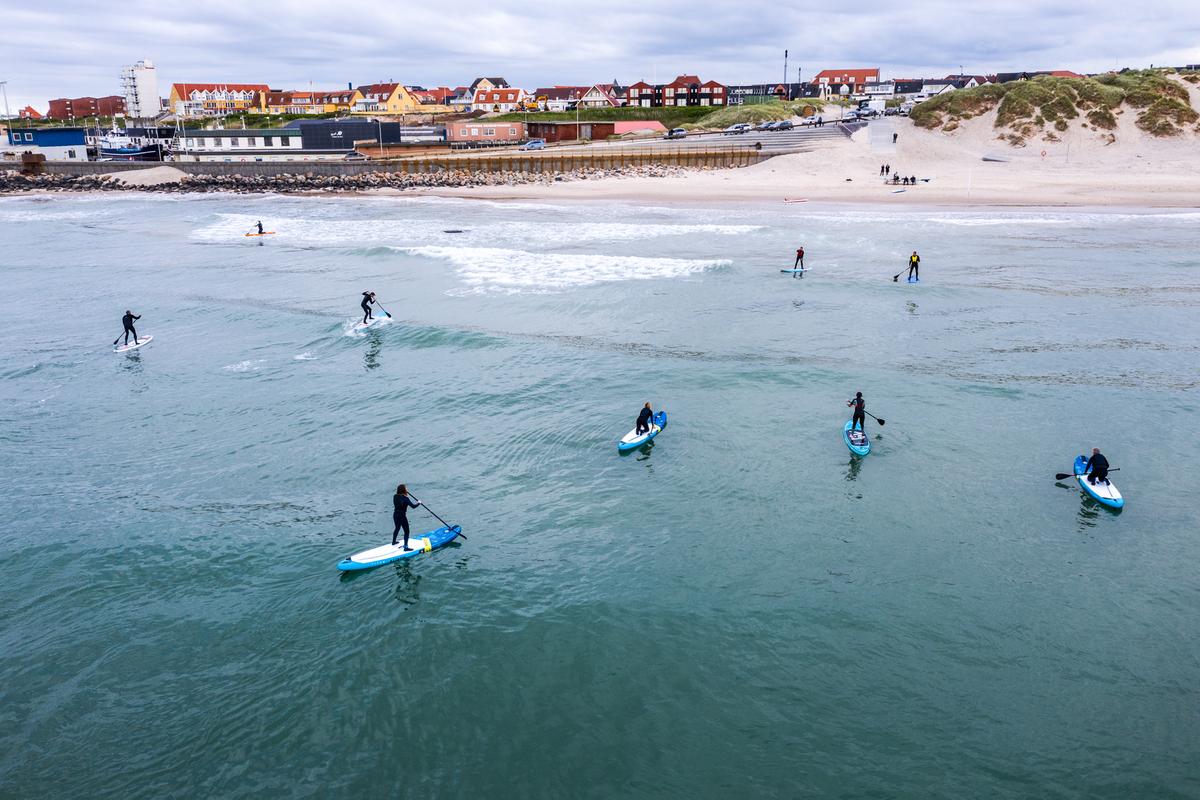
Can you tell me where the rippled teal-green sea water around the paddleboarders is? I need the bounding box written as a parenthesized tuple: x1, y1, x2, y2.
(0, 194, 1200, 799)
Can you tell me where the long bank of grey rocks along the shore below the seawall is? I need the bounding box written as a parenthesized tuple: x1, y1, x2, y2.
(0, 166, 691, 194)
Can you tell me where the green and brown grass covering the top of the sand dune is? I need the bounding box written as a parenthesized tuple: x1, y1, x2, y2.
(911, 70, 1200, 144)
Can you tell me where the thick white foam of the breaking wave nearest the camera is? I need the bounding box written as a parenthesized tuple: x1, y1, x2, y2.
(409, 247, 730, 293)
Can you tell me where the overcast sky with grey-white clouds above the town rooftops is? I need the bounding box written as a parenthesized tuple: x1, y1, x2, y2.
(0, 0, 1200, 113)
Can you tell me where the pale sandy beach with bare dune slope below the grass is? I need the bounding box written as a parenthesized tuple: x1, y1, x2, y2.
(428, 112, 1200, 207)
